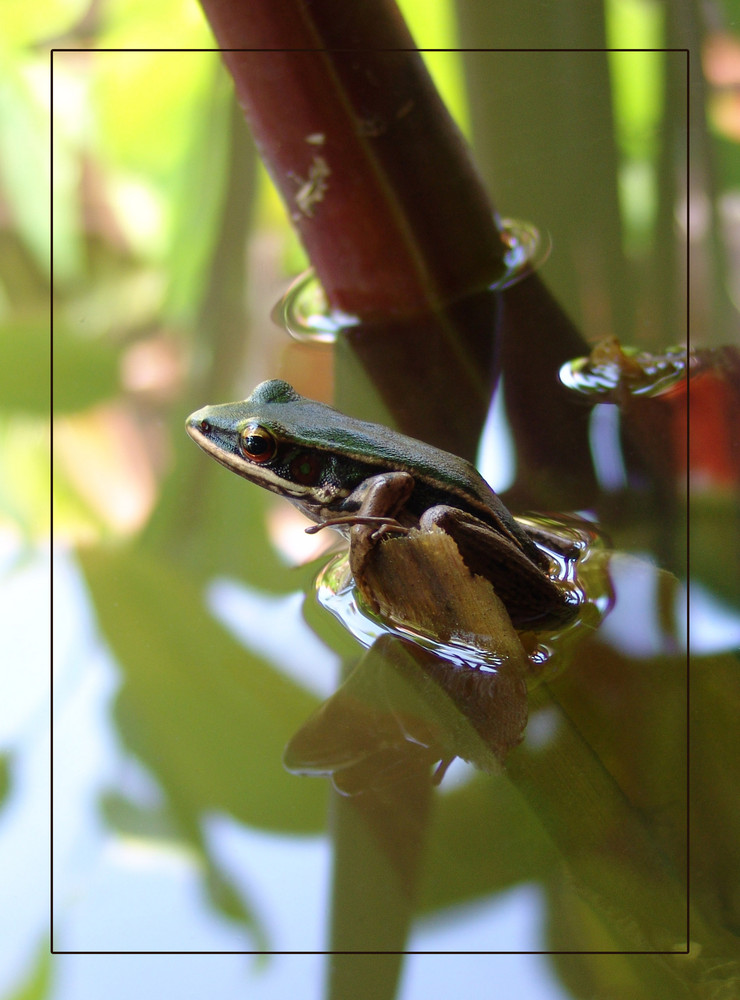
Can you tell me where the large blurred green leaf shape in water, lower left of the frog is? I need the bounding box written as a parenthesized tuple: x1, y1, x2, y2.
(81, 549, 326, 833)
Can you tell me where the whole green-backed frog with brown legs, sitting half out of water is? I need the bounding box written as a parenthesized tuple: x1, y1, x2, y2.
(186, 379, 578, 629)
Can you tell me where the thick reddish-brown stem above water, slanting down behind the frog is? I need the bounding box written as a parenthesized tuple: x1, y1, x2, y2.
(201, 0, 505, 320)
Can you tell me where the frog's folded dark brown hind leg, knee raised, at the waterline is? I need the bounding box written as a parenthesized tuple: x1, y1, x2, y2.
(420, 505, 578, 629)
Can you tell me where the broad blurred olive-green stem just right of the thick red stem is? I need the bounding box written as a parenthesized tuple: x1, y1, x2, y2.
(459, 43, 638, 354)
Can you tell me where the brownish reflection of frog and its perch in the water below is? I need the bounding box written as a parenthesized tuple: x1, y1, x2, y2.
(285, 634, 527, 795)
